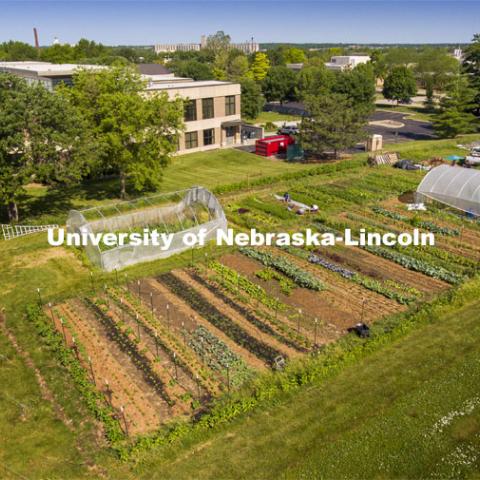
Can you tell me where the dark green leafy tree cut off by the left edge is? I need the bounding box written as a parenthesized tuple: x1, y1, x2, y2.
(0, 74, 95, 221)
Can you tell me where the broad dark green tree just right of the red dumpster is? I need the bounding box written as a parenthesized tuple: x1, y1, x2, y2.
(300, 93, 369, 157)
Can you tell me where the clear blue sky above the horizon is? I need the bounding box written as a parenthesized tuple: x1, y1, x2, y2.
(0, 0, 480, 45)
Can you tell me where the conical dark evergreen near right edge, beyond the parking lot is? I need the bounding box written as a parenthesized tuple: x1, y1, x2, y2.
(433, 74, 479, 138)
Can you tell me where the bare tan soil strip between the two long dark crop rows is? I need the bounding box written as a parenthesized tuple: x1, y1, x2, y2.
(172, 270, 300, 358)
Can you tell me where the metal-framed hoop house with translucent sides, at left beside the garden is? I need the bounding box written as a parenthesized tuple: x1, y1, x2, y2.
(67, 187, 227, 272)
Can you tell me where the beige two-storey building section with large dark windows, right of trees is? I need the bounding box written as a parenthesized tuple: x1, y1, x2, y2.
(147, 79, 241, 154)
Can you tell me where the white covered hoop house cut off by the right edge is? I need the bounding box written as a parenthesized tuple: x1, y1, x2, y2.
(416, 165, 480, 216)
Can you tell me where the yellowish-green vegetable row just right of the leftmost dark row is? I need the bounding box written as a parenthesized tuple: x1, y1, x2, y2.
(108, 287, 218, 395)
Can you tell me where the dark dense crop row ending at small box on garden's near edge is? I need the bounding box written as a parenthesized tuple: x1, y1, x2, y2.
(160, 273, 280, 364)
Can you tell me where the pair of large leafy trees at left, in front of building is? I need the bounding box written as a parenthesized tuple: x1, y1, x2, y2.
(0, 66, 183, 221)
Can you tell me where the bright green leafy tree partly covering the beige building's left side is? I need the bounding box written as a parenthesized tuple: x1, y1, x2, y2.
(62, 67, 183, 197)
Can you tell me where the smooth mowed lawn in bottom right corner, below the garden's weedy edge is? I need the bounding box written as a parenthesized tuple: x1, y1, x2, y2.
(134, 286, 480, 479)
